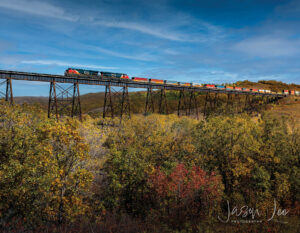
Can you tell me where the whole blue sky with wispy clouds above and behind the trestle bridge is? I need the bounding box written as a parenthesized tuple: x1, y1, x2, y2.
(0, 0, 300, 96)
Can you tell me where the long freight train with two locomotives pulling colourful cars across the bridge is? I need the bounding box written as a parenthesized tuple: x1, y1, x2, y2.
(65, 68, 300, 96)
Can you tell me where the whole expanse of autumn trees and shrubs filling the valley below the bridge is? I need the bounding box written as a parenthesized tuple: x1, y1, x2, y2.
(0, 104, 300, 233)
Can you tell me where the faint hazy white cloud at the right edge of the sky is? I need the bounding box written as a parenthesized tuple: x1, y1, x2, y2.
(233, 36, 300, 58)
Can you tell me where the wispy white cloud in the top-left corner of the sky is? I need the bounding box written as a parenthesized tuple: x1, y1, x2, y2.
(0, 0, 78, 21)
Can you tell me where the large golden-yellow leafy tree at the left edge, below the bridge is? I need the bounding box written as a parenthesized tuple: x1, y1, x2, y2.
(0, 106, 92, 229)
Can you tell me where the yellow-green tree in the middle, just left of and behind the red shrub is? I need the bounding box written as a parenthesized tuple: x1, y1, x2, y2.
(102, 115, 195, 217)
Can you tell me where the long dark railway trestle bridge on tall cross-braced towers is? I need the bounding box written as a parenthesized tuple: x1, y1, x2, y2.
(0, 70, 285, 119)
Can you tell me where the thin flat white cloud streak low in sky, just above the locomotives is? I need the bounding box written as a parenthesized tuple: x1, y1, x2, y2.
(21, 60, 119, 69)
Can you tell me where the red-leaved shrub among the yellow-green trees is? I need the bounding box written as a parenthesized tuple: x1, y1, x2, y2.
(148, 164, 223, 225)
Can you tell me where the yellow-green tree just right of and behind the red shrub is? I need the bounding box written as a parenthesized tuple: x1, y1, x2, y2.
(193, 116, 261, 204)
